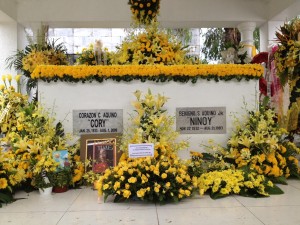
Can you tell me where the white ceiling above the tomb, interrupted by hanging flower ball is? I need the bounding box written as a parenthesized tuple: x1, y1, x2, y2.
(0, 0, 300, 28)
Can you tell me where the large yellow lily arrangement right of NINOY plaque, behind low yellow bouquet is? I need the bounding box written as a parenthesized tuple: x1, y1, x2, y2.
(189, 107, 300, 183)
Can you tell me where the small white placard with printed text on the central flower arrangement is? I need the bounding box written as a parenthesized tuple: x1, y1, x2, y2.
(128, 143, 154, 158)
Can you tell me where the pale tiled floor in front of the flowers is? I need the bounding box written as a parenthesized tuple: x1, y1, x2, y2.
(0, 180, 300, 225)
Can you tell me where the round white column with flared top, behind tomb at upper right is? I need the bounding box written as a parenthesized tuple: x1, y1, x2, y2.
(237, 22, 256, 58)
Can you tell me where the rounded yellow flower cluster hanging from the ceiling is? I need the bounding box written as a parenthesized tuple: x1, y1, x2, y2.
(128, 0, 160, 24)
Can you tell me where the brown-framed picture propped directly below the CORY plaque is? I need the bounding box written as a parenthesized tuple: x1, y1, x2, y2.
(80, 134, 121, 173)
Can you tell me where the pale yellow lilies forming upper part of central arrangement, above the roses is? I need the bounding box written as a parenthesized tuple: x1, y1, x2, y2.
(120, 90, 187, 158)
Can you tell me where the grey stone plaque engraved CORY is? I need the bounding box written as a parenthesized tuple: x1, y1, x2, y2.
(73, 109, 123, 134)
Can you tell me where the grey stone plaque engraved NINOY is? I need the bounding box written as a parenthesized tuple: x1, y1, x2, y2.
(176, 107, 226, 134)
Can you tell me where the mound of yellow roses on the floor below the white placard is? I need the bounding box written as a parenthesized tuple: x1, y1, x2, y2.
(98, 157, 194, 202)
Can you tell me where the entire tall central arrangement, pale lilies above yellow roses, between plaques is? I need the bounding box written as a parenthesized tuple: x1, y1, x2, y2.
(98, 90, 194, 202)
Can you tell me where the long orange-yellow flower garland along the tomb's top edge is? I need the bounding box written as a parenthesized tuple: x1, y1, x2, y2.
(31, 64, 263, 83)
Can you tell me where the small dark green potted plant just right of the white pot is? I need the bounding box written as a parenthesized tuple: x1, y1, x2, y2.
(53, 166, 72, 193)
